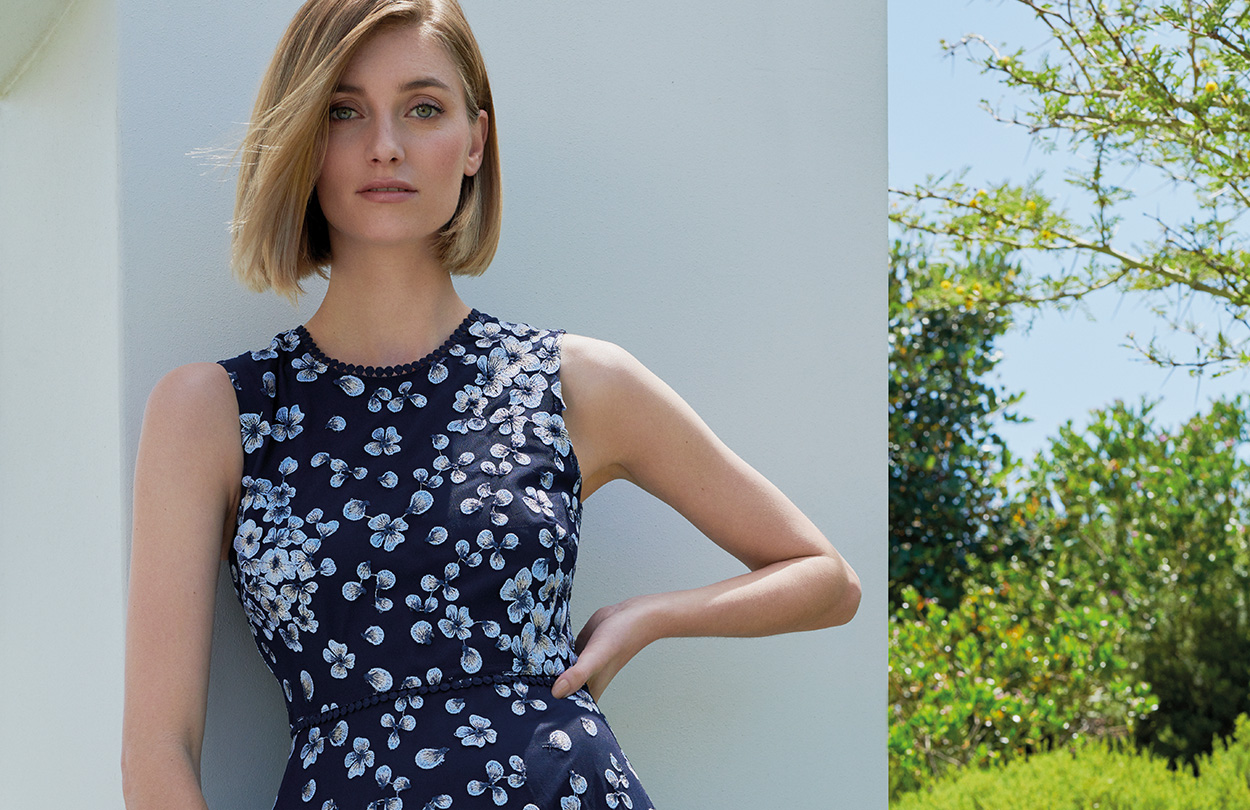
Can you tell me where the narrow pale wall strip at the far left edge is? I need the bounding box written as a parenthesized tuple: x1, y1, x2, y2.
(0, 0, 128, 808)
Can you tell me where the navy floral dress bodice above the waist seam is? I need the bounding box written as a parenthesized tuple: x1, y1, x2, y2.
(221, 310, 580, 733)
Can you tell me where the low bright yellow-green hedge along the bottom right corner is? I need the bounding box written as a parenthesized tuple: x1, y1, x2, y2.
(890, 715, 1250, 810)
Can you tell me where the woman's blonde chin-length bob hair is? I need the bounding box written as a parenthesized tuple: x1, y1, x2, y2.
(231, 0, 501, 300)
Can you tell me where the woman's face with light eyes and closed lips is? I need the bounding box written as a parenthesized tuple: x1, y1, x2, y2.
(316, 25, 486, 255)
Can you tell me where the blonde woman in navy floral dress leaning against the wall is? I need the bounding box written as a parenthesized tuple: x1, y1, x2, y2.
(124, 0, 859, 810)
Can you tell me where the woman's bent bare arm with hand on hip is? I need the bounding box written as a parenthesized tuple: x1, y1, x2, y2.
(554, 335, 860, 698)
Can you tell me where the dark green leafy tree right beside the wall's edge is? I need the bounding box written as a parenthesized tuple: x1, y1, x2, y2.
(889, 243, 1016, 605)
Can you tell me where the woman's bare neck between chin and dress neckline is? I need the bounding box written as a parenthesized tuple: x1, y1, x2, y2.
(305, 245, 470, 366)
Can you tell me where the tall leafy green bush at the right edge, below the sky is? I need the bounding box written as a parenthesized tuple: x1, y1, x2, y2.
(1020, 399, 1250, 763)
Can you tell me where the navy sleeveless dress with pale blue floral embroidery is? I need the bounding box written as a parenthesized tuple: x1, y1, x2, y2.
(220, 310, 651, 810)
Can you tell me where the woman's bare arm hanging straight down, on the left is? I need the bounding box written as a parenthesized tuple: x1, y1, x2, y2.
(121, 363, 243, 810)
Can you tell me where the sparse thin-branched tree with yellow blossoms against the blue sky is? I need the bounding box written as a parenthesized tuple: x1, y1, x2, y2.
(891, 0, 1250, 374)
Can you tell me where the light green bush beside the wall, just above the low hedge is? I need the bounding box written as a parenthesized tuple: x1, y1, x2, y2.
(889, 580, 1150, 796)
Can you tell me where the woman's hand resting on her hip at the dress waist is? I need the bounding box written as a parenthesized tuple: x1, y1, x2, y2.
(551, 596, 661, 700)
